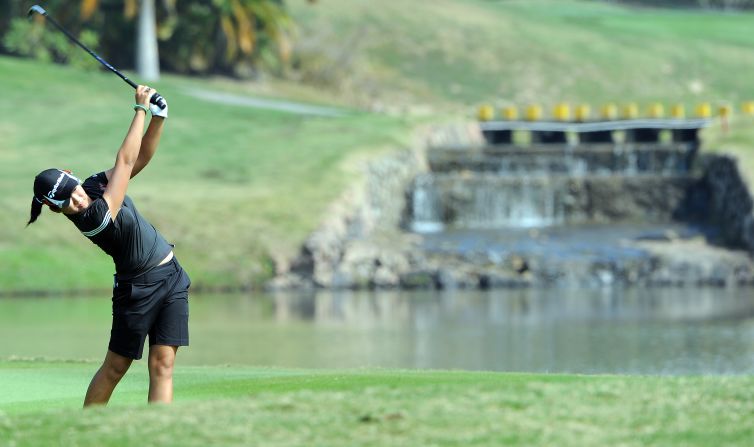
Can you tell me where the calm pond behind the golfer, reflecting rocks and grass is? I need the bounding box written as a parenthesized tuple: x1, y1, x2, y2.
(0, 288, 754, 374)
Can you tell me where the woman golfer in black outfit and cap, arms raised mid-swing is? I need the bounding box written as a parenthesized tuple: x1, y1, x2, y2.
(29, 86, 191, 406)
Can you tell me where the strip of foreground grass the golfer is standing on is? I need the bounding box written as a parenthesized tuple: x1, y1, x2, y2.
(0, 361, 754, 446)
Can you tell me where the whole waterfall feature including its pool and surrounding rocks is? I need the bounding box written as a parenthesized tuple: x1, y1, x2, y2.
(283, 121, 754, 289)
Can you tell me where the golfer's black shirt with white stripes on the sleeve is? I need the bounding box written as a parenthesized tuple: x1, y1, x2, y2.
(66, 172, 173, 279)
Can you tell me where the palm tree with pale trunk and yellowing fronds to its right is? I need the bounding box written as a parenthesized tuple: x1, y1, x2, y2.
(80, 0, 294, 80)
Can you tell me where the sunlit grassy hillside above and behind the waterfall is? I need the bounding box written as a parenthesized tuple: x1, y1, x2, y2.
(291, 0, 754, 108)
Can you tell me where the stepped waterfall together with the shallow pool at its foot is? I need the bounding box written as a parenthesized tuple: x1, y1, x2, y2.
(406, 143, 706, 285)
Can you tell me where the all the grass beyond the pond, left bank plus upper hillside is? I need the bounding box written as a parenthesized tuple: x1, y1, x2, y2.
(0, 0, 754, 291)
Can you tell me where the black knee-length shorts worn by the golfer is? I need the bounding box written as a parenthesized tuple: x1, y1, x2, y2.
(108, 258, 191, 360)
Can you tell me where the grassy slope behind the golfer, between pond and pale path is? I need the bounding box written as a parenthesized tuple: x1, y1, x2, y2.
(0, 58, 409, 290)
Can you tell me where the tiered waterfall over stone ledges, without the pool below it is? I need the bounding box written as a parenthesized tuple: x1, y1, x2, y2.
(408, 143, 689, 233)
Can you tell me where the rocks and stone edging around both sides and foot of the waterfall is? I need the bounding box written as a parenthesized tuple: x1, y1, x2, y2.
(268, 126, 754, 290)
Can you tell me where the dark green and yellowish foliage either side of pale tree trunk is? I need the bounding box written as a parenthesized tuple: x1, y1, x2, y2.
(0, 0, 295, 77)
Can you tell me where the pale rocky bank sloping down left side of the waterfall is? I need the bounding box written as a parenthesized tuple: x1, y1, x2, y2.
(267, 124, 483, 290)
